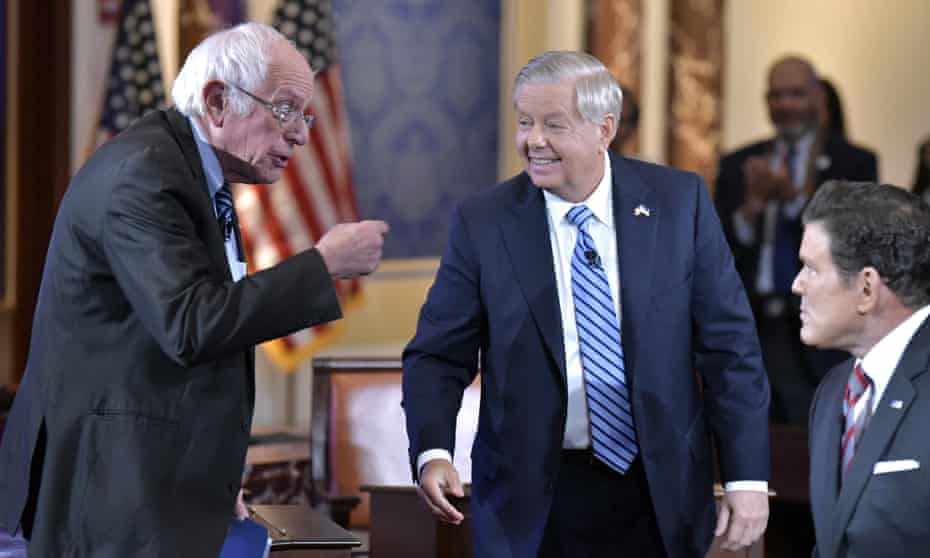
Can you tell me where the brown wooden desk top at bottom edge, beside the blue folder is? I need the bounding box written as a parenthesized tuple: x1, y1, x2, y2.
(251, 505, 362, 558)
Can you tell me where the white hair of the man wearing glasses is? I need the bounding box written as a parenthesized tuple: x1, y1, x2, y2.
(171, 22, 287, 116)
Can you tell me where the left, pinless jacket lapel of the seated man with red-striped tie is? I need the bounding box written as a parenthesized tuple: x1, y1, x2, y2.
(810, 360, 853, 556)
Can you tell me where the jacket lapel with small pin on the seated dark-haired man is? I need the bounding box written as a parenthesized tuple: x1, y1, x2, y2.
(833, 320, 930, 548)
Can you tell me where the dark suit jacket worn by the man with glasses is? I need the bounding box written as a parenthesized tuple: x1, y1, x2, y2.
(0, 111, 340, 558)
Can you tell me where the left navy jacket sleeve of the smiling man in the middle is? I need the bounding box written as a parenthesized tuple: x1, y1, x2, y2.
(403, 209, 487, 478)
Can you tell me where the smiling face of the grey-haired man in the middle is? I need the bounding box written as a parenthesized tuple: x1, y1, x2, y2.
(515, 79, 615, 202)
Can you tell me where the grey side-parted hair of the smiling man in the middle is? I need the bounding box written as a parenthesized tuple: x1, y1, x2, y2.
(513, 50, 623, 129)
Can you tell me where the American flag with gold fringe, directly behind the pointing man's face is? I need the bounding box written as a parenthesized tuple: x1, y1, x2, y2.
(236, 0, 361, 376)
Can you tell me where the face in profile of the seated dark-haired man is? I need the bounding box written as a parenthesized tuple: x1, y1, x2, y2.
(791, 221, 864, 351)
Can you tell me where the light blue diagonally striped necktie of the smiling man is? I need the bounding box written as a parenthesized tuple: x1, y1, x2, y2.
(566, 205, 637, 473)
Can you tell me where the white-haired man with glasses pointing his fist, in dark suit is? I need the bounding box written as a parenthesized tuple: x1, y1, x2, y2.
(0, 24, 388, 557)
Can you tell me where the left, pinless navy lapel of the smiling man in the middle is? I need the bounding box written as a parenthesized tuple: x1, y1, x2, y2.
(501, 177, 566, 393)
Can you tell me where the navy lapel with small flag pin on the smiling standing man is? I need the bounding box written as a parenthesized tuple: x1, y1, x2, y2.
(610, 156, 661, 387)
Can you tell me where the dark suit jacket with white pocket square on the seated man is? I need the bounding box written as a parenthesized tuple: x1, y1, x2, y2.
(809, 320, 930, 558)
